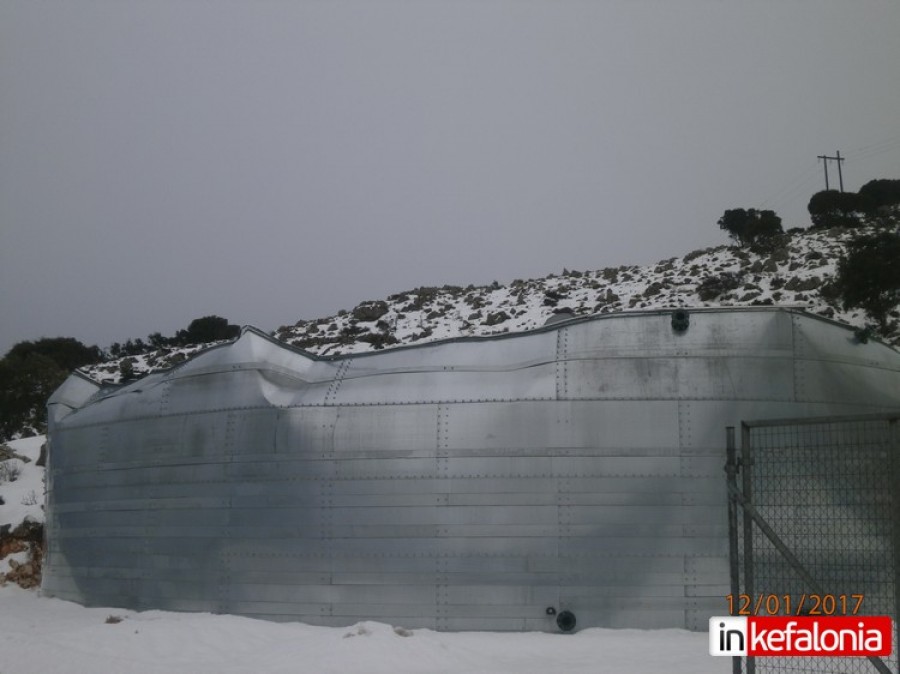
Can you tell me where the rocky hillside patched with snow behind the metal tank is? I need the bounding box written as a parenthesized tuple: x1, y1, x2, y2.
(85, 229, 900, 383)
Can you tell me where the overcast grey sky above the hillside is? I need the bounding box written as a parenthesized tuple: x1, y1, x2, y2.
(0, 0, 900, 353)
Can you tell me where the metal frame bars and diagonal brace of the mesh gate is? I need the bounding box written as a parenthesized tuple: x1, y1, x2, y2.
(725, 413, 900, 674)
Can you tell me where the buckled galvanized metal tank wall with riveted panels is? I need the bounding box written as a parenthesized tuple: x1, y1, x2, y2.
(43, 308, 900, 630)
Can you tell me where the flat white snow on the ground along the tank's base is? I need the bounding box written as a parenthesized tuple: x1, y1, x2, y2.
(0, 586, 731, 674)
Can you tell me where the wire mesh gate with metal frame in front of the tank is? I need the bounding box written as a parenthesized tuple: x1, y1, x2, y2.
(725, 414, 900, 674)
